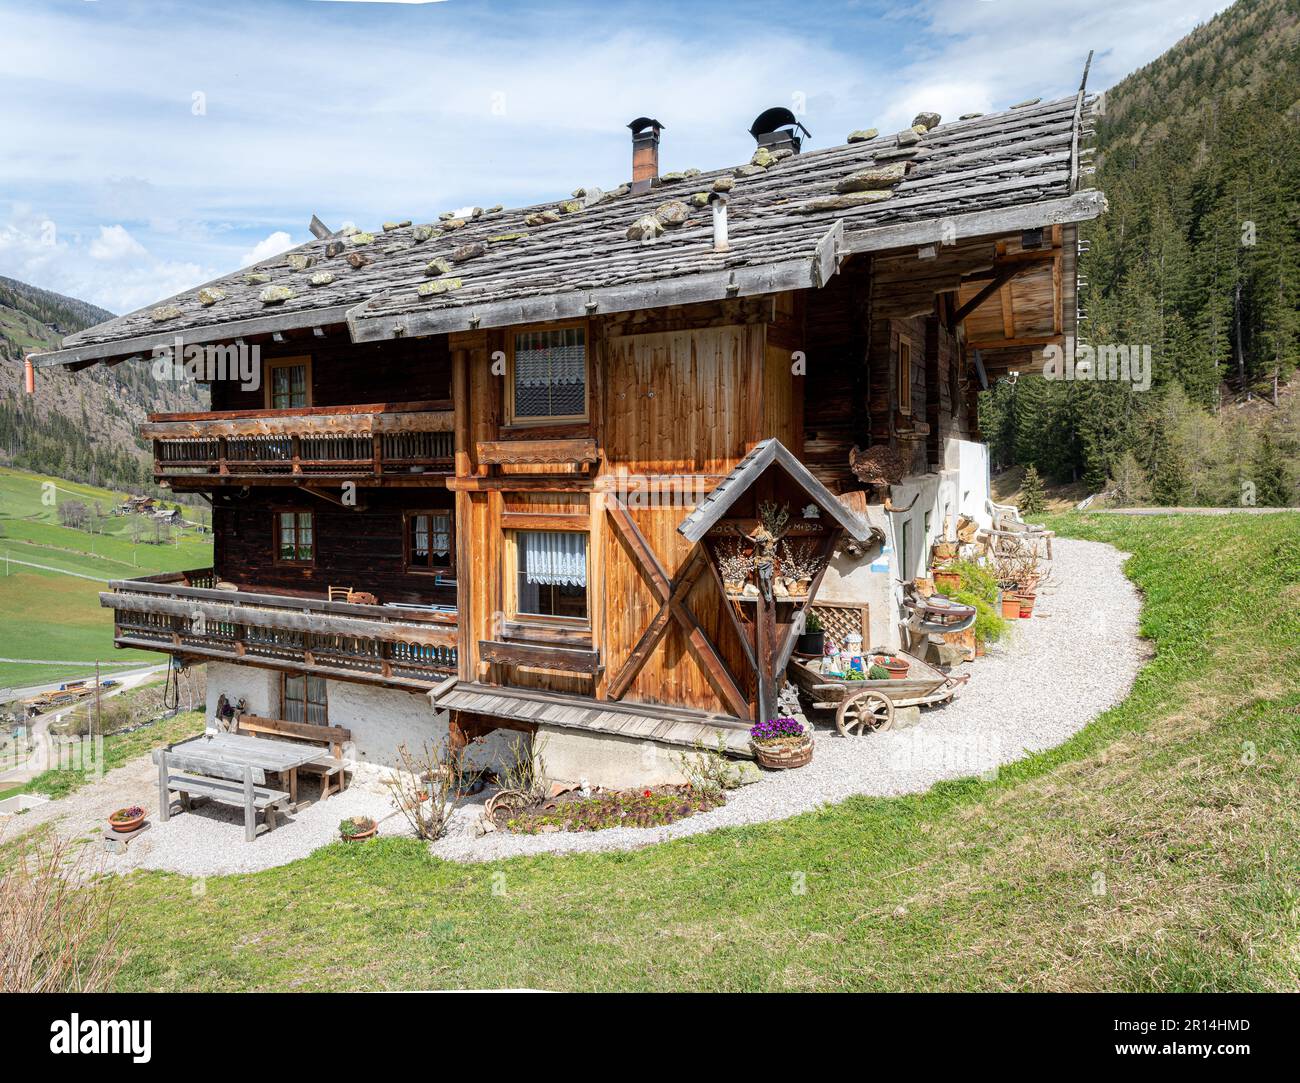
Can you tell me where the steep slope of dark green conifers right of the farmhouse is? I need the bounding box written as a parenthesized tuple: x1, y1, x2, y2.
(982, 0, 1300, 503)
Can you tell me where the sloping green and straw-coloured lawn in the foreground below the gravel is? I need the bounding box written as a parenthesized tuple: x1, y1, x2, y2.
(58, 515, 1300, 989)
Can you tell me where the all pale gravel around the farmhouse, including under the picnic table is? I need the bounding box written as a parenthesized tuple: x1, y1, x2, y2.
(0, 540, 1144, 876)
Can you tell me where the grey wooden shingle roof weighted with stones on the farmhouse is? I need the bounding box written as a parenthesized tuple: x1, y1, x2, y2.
(38, 96, 1104, 364)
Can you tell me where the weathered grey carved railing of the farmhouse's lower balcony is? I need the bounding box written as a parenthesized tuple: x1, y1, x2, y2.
(99, 568, 456, 689)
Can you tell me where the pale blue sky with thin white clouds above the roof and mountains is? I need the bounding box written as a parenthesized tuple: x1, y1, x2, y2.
(0, 0, 1227, 312)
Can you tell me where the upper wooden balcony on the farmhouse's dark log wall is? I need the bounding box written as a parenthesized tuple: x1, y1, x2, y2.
(140, 400, 455, 489)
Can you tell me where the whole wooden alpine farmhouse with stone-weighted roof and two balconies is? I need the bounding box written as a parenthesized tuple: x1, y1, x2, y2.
(34, 82, 1104, 785)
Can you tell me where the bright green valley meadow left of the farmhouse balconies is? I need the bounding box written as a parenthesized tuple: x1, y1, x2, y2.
(0, 467, 212, 688)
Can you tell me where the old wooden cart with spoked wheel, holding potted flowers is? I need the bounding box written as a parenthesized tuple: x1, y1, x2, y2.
(787, 651, 970, 737)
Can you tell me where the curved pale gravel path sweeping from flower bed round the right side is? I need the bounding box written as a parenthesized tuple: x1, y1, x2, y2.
(430, 538, 1145, 862)
